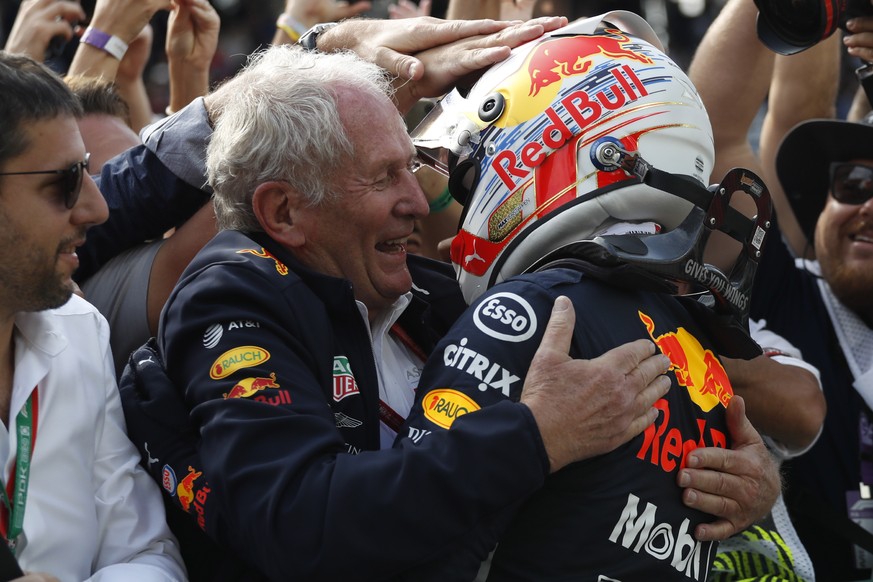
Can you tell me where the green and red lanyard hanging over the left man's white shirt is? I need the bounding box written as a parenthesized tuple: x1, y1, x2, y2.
(0, 386, 39, 550)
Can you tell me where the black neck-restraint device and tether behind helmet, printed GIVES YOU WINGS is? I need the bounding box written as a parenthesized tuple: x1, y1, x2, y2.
(530, 145, 771, 357)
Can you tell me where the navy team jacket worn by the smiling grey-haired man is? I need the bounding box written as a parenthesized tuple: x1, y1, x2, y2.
(136, 231, 548, 581)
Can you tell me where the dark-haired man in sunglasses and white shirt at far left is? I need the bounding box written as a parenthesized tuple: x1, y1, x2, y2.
(0, 51, 185, 581)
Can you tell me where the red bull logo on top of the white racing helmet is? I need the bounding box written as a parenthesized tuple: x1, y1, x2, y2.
(527, 29, 652, 97)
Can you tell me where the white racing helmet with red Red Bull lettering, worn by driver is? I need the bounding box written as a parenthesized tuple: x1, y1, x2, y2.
(412, 11, 769, 342)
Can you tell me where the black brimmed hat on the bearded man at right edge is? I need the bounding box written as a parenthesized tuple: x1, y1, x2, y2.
(776, 113, 873, 242)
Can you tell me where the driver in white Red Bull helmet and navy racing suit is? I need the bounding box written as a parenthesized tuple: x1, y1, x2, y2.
(398, 11, 770, 582)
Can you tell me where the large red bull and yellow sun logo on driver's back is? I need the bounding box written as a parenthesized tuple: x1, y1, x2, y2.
(638, 311, 734, 412)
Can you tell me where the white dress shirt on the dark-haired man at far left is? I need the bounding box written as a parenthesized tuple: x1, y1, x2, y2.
(0, 296, 186, 582)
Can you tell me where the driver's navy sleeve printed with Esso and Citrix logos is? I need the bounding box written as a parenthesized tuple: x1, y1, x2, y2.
(395, 281, 554, 582)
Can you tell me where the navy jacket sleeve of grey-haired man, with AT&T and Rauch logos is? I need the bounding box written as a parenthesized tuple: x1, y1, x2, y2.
(153, 268, 548, 580)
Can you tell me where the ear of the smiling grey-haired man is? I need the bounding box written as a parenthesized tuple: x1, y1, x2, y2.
(252, 182, 306, 248)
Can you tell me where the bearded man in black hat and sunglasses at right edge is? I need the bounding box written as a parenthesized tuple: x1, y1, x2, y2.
(752, 119, 873, 580)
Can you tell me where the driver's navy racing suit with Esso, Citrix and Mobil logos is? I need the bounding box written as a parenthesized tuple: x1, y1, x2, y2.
(400, 269, 733, 582)
